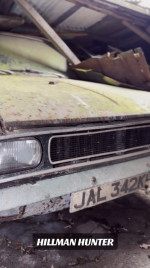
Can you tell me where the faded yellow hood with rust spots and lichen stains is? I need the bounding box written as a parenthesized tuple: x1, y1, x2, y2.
(0, 75, 150, 126)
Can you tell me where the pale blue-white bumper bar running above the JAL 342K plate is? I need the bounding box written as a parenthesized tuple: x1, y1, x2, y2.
(0, 156, 150, 214)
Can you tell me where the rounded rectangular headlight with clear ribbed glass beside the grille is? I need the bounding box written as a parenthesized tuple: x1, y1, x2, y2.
(0, 138, 42, 173)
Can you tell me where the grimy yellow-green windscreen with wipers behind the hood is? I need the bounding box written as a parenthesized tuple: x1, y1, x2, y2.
(0, 33, 67, 77)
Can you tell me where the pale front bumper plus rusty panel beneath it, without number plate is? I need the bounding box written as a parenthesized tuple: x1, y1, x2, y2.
(0, 156, 150, 220)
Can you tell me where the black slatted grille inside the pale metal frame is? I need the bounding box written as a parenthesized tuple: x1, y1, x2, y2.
(50, 126, 150, 163)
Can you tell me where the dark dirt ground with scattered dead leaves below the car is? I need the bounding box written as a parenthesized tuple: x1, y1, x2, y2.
(0, 189, 150, 268)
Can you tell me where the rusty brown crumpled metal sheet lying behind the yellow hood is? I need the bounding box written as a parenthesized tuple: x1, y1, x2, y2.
(74, 48, 150, 90)
